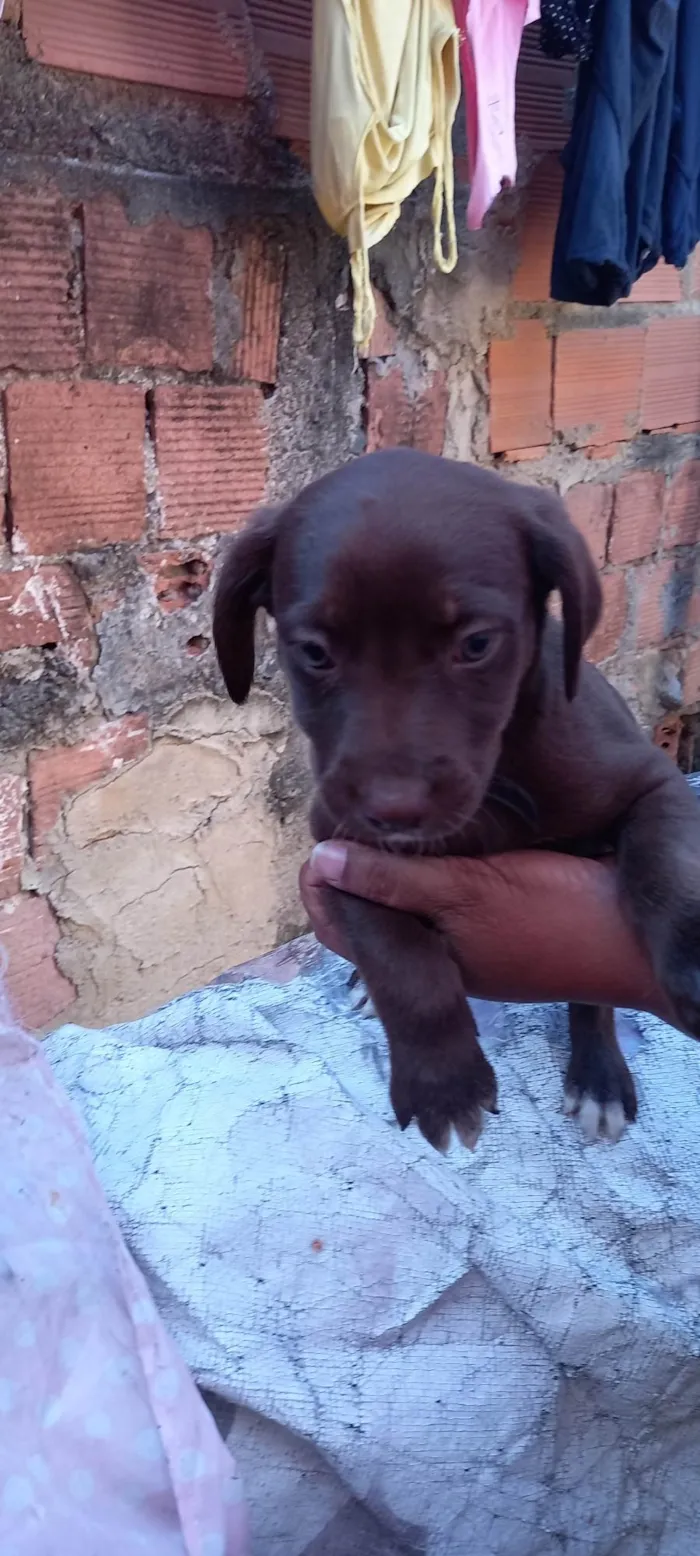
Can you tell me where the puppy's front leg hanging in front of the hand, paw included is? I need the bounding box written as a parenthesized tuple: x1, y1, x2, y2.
(322, 890, 498, 1151)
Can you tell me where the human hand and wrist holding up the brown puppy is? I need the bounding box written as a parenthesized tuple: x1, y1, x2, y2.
(300, 842, 674, 1022)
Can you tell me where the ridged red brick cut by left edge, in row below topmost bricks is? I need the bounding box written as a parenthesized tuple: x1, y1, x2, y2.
(0, 188, 81, 372)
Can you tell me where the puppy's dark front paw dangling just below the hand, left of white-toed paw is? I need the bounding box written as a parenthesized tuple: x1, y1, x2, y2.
(390, 1041, 498, 1151)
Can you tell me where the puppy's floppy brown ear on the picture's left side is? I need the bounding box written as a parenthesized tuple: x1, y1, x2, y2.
(212, 507, 283, 702)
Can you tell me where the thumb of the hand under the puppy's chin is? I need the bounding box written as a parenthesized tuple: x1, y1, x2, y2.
(308, 840, 453, 918)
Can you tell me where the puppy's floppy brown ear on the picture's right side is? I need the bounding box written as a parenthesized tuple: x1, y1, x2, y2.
(526, 490, 602, 702)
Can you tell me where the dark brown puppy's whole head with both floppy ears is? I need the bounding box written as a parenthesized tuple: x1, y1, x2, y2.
(213, 450, 600, 848)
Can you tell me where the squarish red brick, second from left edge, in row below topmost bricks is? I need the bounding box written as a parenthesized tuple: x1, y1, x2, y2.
(84, 198, 213, 373)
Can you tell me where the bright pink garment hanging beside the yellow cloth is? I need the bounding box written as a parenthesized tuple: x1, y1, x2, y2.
(454, 0, 540, 229)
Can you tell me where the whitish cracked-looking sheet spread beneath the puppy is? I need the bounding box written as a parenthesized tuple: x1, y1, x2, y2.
(47, 908, 700, 1556)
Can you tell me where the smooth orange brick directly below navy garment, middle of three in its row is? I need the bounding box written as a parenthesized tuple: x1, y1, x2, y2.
(554, 328, 644, 443)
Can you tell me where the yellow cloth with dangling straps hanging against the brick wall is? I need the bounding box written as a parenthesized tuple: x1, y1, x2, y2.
(311, 0, 460, 355)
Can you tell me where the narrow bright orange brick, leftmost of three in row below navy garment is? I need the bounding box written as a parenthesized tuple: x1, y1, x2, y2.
(488, 319, 552, 454)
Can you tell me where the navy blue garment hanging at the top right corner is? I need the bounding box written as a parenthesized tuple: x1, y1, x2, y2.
(551, 0, 700, 307)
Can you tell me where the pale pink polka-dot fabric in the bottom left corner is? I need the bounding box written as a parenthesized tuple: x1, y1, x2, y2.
(0, 968, 247, 1556)
